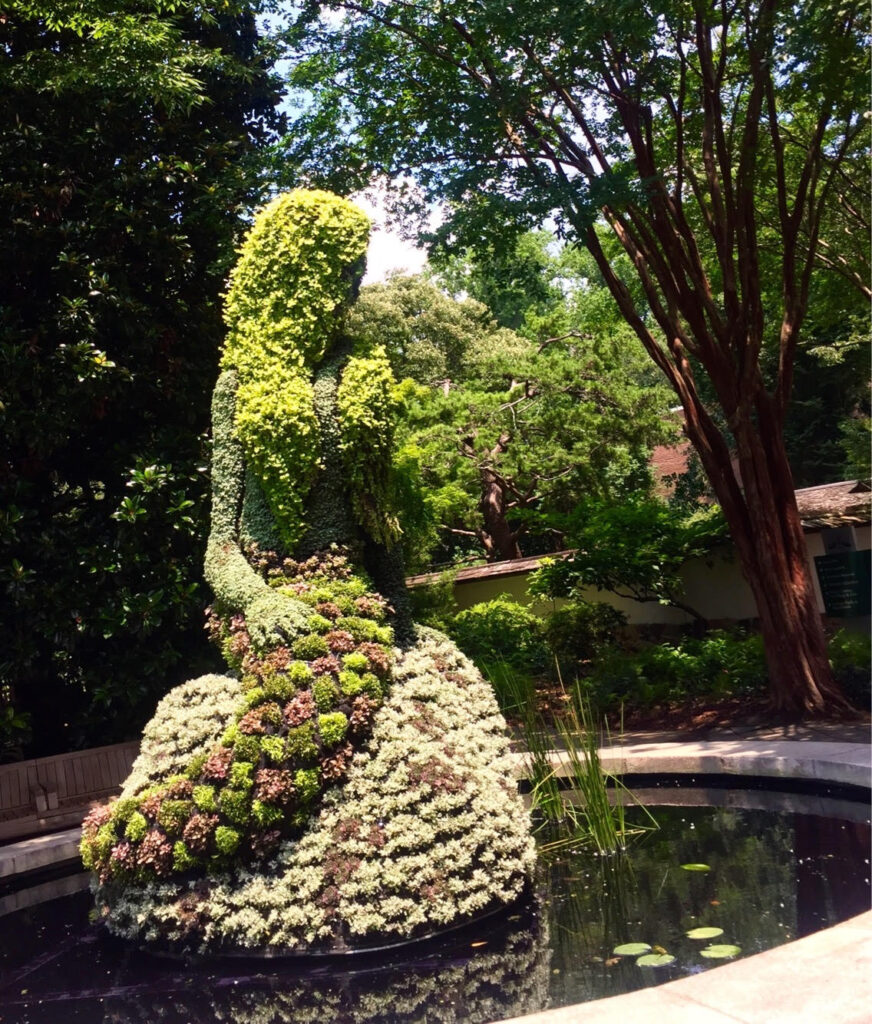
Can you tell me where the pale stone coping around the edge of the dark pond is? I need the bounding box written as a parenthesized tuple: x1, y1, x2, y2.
(0, 739, 872, 1024)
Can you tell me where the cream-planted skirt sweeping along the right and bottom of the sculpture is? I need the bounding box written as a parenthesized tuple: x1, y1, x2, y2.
(92, 632, 534, 958)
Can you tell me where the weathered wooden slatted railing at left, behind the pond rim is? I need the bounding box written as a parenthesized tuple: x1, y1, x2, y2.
(0, 741, 139, 842)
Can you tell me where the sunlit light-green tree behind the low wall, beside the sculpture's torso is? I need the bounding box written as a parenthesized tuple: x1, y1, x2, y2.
(350, 276, 667, 566)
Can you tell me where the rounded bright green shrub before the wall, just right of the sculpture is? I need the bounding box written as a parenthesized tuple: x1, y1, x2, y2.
(448, 594, 551, 672)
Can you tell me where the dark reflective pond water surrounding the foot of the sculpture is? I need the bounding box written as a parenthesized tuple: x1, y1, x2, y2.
(0, 790, 870, 1024)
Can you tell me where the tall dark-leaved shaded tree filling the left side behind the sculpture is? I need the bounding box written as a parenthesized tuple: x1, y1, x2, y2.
(0, 0, 278, 754)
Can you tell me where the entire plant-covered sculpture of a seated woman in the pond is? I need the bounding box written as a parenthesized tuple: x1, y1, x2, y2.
(82, 191, 532, 953)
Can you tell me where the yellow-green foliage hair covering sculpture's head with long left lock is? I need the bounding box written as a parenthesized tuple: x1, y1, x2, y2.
(223, 190, 369, 549)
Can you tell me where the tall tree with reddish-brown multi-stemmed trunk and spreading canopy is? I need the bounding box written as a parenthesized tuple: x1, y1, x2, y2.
(291, 0, 869, 715)
